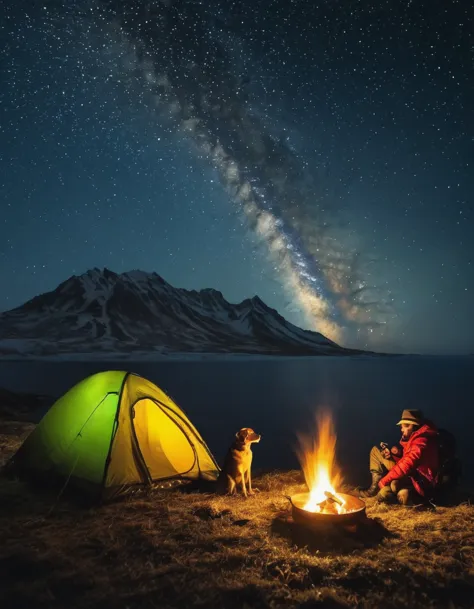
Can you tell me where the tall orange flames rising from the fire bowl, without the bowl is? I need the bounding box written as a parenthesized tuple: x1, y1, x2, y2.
(296, 410, 346, 514)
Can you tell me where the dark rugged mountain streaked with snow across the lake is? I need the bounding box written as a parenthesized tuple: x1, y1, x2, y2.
(0, 269, 354, 356)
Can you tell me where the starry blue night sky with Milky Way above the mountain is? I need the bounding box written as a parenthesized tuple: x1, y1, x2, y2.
(0, 0, 474, 353)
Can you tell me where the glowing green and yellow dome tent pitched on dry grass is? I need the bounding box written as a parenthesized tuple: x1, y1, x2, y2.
(9, 371, 219, 499)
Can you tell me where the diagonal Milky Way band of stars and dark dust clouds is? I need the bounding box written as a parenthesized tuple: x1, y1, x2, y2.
(90, 0, 393, 341)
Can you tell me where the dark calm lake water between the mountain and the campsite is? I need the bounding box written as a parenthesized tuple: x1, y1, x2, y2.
(0, 357, 474, 483)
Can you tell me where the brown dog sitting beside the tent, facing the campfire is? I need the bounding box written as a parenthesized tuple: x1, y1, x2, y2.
(217, 427, 261, 497)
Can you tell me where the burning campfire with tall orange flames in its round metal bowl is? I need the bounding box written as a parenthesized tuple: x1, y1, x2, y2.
(291, 411, 365, 522)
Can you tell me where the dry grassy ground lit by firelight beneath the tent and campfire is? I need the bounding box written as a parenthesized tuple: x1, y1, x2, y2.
(0, 421, 474, 609)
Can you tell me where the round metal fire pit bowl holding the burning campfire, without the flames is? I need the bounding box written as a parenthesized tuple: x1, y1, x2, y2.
(288, 493, 365, 525)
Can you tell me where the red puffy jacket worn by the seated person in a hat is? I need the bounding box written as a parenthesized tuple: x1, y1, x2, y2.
(379, 421, 439, 496)
